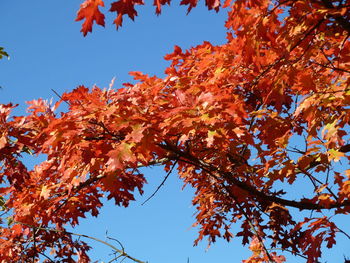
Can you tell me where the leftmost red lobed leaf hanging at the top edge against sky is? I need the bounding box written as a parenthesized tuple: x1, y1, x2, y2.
(75, 0, 105, 36)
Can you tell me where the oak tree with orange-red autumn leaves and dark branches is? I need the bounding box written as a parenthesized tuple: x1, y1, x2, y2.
(0, 0, 350, 263)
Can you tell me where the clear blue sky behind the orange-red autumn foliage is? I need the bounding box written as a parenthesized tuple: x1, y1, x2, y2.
(0, 0, 346, 263)
